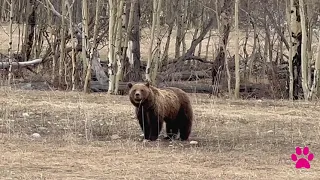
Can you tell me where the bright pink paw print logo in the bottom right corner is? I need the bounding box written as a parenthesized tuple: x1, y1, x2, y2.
(291, 146, 314, 169)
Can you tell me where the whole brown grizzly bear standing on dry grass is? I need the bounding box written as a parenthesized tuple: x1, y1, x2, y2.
(128, 82, 193, 141)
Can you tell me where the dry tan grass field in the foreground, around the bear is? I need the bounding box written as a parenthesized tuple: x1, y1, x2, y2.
(0, 88, 320, 180)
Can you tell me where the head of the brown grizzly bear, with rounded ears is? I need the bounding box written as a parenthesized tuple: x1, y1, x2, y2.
(128, 82, 152, 105)
